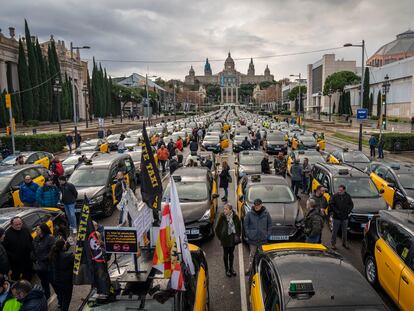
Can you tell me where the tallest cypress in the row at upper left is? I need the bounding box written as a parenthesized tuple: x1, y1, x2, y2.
(24, 20, 40, 120)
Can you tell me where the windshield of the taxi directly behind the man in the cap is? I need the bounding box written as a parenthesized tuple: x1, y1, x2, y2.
(247, 185, 295, 203)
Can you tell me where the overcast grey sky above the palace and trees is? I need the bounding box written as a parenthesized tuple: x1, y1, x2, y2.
(0, 0, 414, 80)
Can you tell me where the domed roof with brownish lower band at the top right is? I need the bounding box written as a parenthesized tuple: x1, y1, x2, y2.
(367, 29, 414, 67)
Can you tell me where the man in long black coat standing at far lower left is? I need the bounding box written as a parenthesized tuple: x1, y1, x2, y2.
(3, 216, 33, 281)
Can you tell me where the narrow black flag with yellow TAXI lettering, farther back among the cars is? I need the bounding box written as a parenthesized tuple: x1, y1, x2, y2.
(141, 122, 162, 211)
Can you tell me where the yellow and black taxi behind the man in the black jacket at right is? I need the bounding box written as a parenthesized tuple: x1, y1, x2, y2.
(312, 163, 388, 234)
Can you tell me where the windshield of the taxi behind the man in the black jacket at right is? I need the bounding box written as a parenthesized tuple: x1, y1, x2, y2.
(333, 177, 379, 198)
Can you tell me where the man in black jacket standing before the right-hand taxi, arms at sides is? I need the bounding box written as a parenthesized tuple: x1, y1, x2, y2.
(329, 185, 354, 250)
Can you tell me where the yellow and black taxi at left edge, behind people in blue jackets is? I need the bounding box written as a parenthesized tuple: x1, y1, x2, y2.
(0, 164, 49, 208)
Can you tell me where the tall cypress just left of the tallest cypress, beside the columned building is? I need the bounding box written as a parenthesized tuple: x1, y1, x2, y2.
(18, 40, 33, 121)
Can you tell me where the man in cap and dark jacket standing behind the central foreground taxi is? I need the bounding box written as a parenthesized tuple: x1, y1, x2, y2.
(243, 199, 272, 274)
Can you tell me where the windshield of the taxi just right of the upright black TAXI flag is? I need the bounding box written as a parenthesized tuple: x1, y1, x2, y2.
(163, 182, 208, 202)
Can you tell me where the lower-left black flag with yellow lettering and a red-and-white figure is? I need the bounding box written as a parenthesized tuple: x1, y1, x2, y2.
(73, 199, 111, 295)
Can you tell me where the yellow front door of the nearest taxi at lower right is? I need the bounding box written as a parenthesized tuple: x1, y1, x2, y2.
(374, 219, 405, 304)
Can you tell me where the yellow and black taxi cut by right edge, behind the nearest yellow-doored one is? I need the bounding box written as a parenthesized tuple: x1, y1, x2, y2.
(367, 162, 414, 209)
